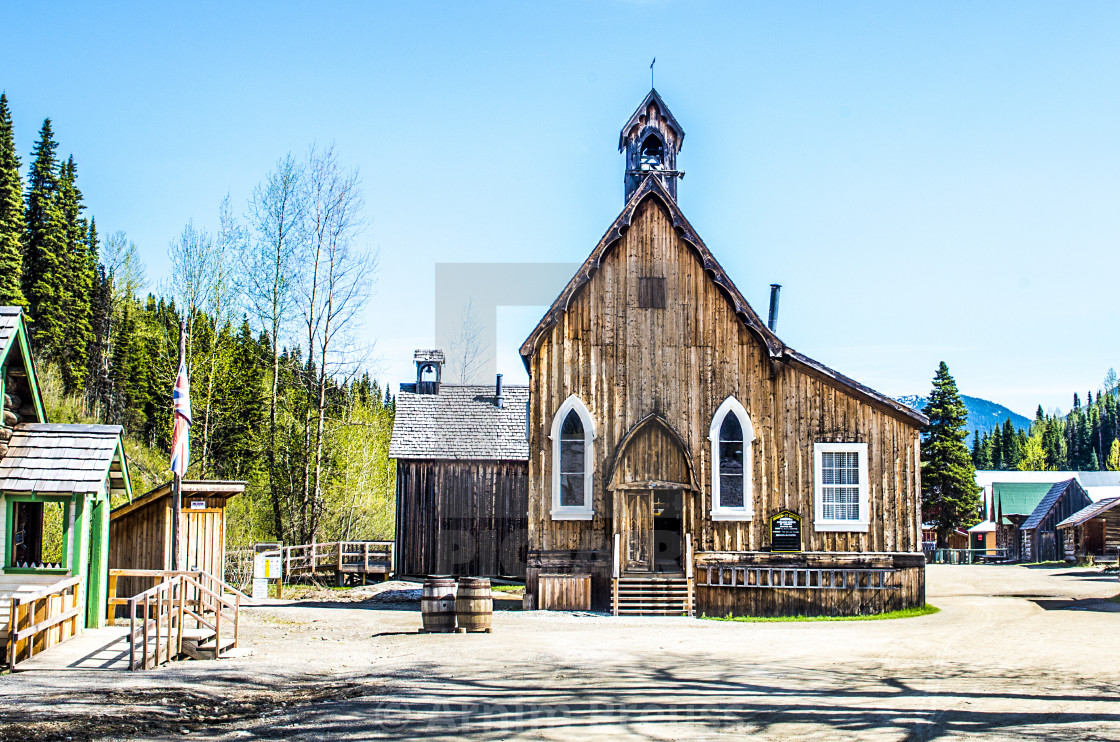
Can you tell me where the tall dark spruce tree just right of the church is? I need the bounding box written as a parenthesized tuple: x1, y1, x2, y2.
(922, 361, 980, 547)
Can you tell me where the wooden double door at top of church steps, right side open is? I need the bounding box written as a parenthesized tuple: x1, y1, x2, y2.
(619, 489, 684, 574)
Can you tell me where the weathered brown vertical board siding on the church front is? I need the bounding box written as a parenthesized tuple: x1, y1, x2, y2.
(529, 198, 921, 609)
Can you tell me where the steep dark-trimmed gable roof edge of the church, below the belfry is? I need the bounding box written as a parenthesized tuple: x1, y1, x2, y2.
(521, 176, 928, 426)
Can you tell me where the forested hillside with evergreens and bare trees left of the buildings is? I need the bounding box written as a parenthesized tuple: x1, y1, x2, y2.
(0, 95, 394, 547)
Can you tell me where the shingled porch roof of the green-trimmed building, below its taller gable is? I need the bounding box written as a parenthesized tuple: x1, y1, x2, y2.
(0, 423, 129, 493)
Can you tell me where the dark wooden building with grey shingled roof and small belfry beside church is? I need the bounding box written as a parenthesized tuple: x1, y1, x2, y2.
(389, 350, 529, 579)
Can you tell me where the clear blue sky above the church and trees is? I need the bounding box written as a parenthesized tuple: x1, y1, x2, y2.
(0, 1, 1120, 415)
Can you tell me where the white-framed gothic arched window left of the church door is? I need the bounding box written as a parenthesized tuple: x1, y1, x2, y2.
(550, 395, 595, 520)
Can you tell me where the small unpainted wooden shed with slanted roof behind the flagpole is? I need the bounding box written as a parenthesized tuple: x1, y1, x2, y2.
(109, 480, 245, 597)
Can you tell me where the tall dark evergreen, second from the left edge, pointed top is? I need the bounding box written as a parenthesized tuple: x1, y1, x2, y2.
(24, 119, 66, 361)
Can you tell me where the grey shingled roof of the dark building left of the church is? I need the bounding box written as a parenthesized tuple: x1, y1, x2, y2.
(389, 383, 529, 461)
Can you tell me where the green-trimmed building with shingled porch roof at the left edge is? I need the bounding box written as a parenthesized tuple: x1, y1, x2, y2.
(0, 307, 132, 657)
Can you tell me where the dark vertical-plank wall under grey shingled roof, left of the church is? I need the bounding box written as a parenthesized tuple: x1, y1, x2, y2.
(396, 458, 529, 578)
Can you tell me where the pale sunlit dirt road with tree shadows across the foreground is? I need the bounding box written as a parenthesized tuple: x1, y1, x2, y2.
(0, 566, 1120, 742)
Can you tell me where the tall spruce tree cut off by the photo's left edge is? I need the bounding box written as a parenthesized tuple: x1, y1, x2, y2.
(0, 93, 27, 307)
